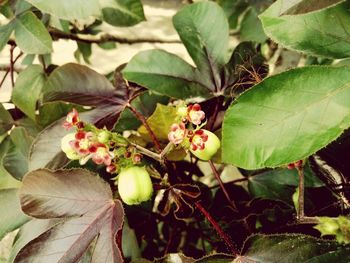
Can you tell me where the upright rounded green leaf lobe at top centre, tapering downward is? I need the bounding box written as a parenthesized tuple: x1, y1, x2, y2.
(173, 2, 229, 88)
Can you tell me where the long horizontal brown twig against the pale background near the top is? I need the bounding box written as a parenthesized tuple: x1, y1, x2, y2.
(49, 29, 181, 45)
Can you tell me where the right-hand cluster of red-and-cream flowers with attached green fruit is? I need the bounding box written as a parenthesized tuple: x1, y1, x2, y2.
(168, 104, 220, 160)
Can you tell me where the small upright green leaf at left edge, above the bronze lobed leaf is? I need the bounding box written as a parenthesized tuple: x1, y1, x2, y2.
(3, 127, 33, 180)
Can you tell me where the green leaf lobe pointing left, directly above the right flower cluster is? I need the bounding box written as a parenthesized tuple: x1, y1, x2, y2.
(123, 50, 209, 99)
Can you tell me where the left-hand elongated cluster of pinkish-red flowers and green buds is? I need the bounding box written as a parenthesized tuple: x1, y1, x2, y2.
(61, 109, 142, 173)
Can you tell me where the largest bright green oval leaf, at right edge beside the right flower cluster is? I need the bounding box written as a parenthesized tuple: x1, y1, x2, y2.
(222, 67, 350, 169)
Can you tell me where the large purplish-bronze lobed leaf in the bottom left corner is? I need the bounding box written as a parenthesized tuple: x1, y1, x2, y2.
(15, 169, 124, 263)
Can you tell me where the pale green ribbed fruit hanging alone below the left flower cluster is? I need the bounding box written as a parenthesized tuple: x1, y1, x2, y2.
(118, 166, 153, 205)
